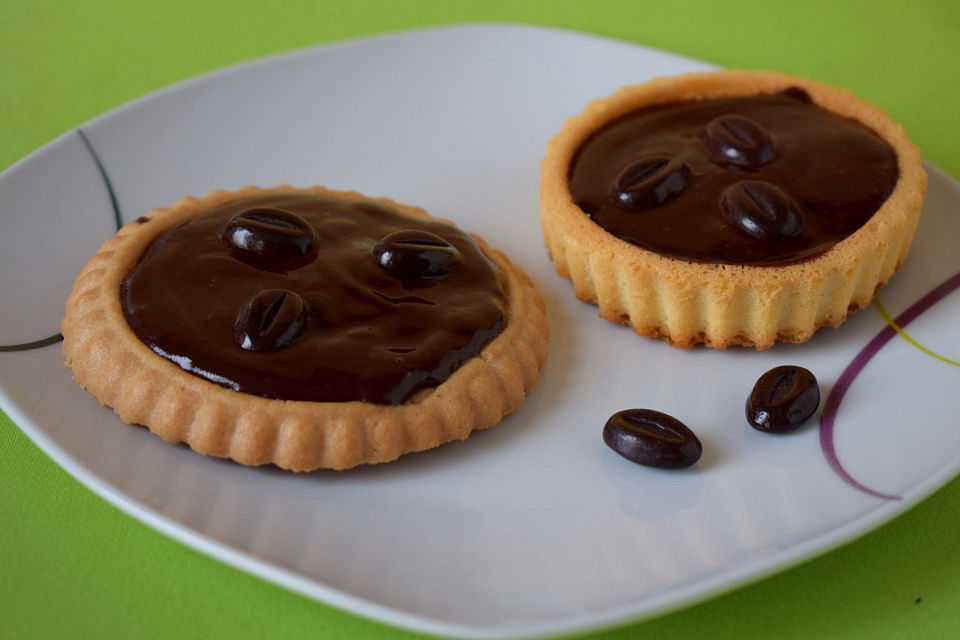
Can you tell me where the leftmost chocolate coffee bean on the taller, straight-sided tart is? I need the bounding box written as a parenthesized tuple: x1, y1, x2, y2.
(613, 156, 690, 211)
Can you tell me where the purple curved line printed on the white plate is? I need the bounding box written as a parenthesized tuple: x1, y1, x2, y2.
(820, 271, 960, 500)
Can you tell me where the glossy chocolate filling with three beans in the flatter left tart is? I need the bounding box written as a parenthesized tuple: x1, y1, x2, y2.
(120, 194, 506, 405)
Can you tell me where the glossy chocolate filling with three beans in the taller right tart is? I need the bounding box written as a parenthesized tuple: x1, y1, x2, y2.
(568, 87, 899, 266)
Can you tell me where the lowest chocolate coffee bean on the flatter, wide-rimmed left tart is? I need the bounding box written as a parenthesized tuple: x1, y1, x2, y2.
(233, 289, 307, 351)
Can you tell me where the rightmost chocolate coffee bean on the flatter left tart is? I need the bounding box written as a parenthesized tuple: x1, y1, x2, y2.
(373, 229, 463, 278)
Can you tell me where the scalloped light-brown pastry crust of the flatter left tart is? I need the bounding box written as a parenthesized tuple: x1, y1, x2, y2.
(60, 185, 547, 471)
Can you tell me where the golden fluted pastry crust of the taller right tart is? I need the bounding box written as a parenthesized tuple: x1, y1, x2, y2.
(540, 71, 927, 349)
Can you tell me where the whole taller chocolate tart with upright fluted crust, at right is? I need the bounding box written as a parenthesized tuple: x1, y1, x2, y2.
(540, 71, 926, 349)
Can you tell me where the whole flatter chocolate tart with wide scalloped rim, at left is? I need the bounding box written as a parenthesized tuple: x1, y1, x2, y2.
(61, 185, 547, 471)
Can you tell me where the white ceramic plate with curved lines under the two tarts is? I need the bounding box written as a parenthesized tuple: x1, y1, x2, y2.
(0, 25, 960, 638)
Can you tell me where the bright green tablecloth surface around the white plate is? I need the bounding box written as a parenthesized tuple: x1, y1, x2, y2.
(0, 0, 960, 640)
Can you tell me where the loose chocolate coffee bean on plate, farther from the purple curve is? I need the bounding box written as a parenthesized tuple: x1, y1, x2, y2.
(603, 409, 703, 469)
